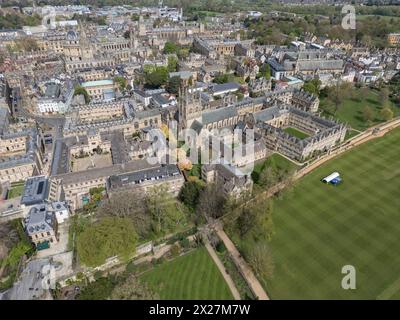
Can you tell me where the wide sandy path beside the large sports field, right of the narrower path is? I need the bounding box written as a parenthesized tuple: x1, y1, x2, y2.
(215, 224, 269, 300)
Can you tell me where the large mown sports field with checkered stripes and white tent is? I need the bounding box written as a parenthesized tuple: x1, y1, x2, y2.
(266, 129, 400, 299)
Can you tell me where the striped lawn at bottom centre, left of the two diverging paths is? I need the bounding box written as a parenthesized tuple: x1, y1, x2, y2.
(140, 248, 233, 300)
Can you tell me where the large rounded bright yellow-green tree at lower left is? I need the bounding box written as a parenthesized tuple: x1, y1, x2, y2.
(77, 217, 138, 267)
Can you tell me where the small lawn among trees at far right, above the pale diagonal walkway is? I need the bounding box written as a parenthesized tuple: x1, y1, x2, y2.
(321, 89, 400, 130)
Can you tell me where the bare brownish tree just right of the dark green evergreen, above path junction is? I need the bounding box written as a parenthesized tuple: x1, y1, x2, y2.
(196, 183, 226, 219)
